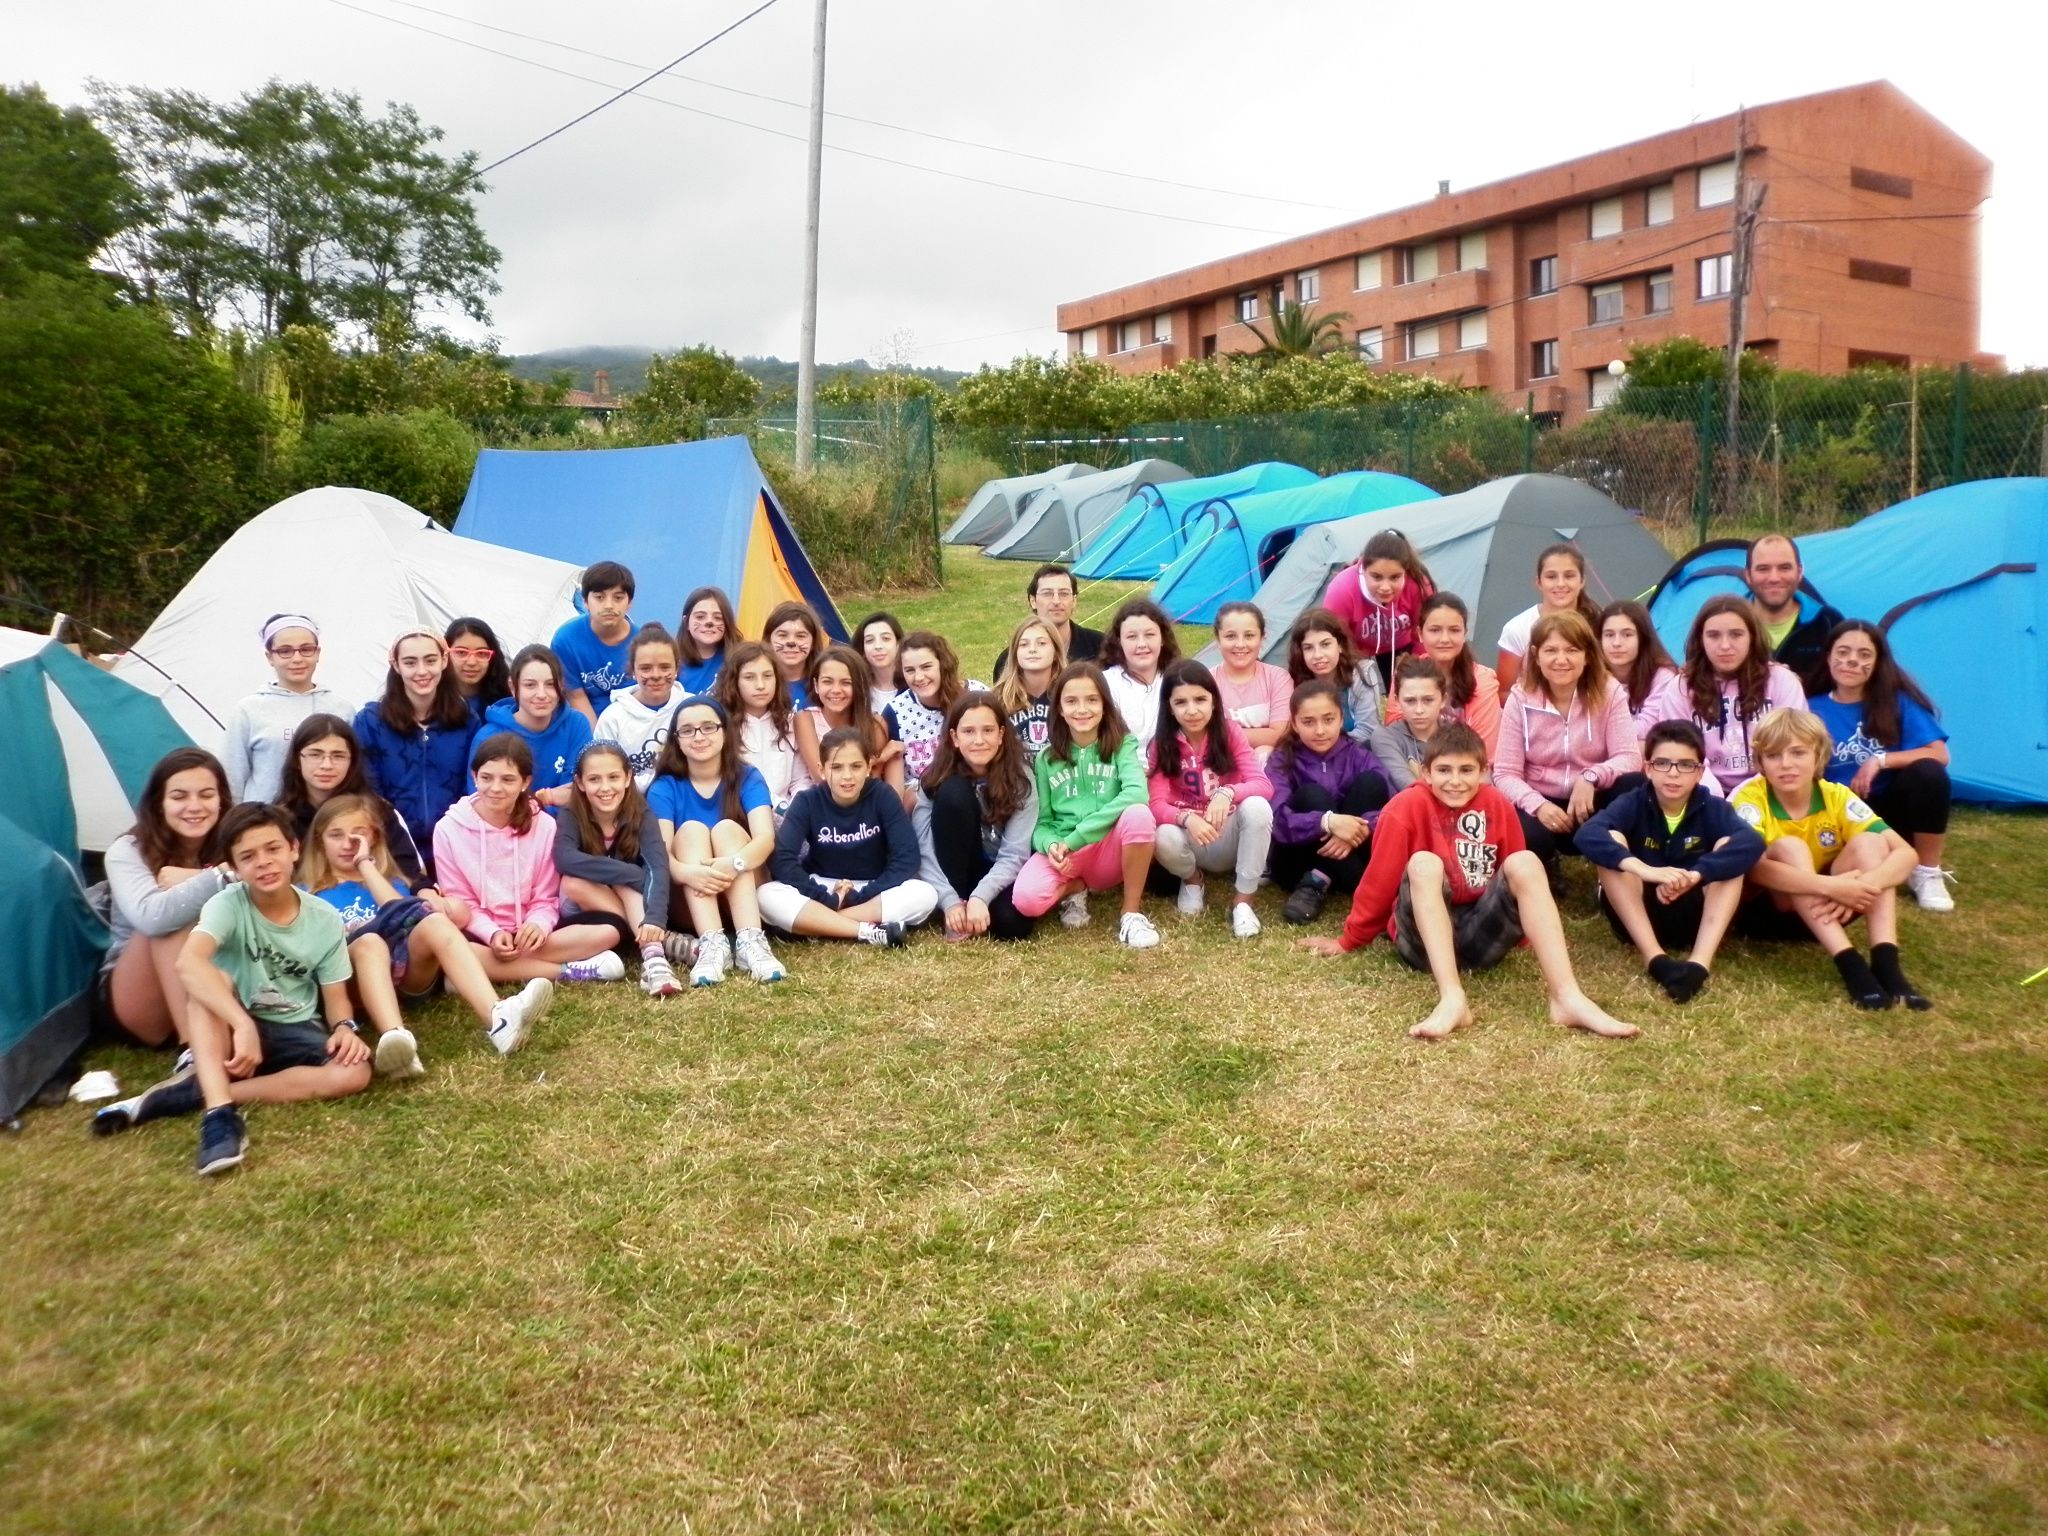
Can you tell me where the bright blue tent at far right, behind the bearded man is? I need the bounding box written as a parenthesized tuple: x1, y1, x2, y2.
(1651, 477, 2048, 805)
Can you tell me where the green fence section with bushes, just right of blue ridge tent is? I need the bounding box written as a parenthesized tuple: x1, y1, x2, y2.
(707, 397, 938, 590)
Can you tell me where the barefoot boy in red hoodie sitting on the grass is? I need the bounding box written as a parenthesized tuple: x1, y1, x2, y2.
(1300, 721, 1636, 1040)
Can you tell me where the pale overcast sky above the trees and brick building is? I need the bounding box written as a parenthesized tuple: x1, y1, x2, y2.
(19, 0, 2048, 369)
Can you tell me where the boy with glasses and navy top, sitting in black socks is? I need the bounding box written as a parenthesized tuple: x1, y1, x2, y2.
(1573, 721, 1763, 1004)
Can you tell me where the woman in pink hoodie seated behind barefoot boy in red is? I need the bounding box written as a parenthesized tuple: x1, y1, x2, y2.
(1493, 608, 1642, 870)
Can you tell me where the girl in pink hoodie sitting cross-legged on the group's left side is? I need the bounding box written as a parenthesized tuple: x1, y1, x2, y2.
(434, 731, 627, 981)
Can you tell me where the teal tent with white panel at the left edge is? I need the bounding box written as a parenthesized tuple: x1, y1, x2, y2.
(0, 631, 188, 1118)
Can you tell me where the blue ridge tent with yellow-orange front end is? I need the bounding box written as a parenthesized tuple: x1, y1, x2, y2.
(455, 438, 846, 639)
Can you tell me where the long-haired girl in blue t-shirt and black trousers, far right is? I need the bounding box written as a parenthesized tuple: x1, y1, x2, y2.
(1806, 618, 1956, 911)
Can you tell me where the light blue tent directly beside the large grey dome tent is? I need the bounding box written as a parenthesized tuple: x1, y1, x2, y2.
(1153, 469, 1436, 625)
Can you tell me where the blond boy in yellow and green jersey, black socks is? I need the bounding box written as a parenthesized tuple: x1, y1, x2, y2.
(1729, 709, 1933, 1010)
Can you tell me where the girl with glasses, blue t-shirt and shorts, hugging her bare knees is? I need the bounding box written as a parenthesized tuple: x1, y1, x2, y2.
(647, 694, 784, 987)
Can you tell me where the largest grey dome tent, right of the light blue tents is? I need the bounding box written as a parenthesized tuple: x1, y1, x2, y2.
(1202, 475, 1671, 664)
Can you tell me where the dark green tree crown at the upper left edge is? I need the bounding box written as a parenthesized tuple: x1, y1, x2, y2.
(0, 86, 135, 293)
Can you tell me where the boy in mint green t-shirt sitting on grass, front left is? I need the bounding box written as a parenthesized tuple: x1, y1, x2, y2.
(92, 803, 371, 1174)
